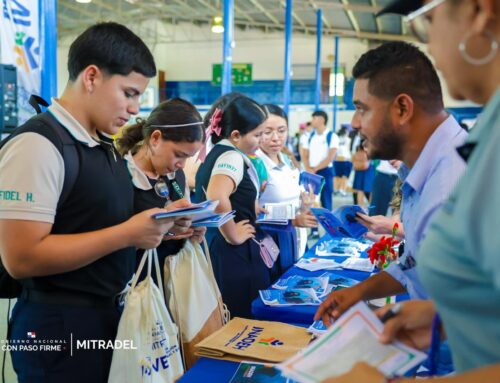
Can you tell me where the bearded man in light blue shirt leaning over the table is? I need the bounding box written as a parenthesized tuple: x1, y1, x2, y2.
(316, 42, 467, 323)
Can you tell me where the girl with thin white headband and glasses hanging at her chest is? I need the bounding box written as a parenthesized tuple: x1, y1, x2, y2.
(116, 98, 205, 276)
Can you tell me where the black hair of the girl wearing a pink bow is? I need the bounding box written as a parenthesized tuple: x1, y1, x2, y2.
(211, 96, 268, 144)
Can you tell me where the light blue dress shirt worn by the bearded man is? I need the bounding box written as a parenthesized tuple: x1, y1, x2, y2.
(385, 116, 467, 299)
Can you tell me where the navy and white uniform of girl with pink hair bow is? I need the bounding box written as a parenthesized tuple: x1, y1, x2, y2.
(196, 140, 271, 318)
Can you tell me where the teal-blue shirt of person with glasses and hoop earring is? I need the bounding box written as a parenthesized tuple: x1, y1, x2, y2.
(417, 89, 500, 380)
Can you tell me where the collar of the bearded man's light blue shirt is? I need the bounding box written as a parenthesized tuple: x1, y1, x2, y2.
(404, 115, 467, 193)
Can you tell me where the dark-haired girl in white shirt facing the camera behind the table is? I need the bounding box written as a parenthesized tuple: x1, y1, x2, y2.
(256, 104, 318, 268)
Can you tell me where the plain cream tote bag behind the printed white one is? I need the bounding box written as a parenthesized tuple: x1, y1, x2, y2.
(164, 240, 229, 368)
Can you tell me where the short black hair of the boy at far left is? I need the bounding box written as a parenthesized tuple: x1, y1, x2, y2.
(68, 22, 156, 81)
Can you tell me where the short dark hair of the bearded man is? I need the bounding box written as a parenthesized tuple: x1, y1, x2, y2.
(352, 41, 444, 114)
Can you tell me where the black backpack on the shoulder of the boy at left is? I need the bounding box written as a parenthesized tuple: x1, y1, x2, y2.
(0, 95, 80, 298)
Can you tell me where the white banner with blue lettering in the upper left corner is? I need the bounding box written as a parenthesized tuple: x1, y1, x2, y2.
(0, 0, 41, 124)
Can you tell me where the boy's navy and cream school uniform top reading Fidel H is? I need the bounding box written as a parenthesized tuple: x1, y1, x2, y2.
(0, 99, 135, 297)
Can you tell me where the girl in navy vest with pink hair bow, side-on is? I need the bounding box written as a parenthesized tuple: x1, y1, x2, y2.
(196, 96, 271, 318)
